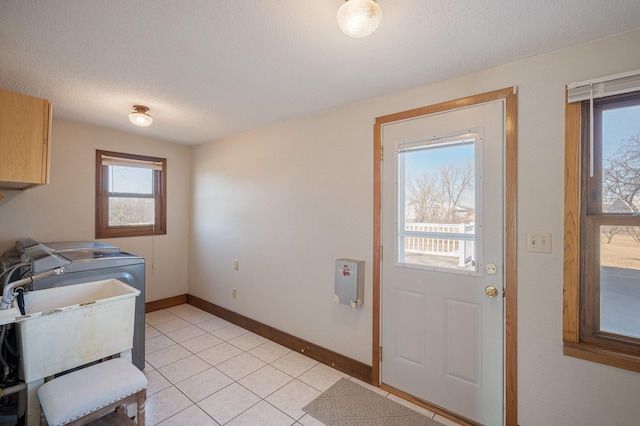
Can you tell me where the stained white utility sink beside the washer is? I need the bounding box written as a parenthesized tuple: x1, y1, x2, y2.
(11, 279, 140, 383)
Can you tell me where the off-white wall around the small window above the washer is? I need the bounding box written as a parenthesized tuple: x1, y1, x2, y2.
(0, 120, 190, 302)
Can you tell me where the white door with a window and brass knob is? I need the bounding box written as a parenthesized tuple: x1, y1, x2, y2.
(381, 100, 505, 425)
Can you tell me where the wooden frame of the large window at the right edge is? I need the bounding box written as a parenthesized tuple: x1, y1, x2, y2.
(562, 91, 640, 372)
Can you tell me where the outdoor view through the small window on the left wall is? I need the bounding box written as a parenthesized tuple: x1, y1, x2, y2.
(109, 166, 155, 226)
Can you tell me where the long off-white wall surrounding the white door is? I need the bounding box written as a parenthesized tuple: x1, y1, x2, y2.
(189, 30, 640, 425)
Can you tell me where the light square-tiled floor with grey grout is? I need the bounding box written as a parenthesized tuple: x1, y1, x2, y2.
(144, 304, 456, 426)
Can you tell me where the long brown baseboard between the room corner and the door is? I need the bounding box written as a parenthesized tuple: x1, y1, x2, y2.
(186, 294, 371, 383)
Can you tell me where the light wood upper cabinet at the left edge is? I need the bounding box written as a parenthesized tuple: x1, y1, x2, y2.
(0, 89, 51, 189)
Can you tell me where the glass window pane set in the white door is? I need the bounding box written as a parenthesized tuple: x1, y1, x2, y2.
(396, 134, 477, 271)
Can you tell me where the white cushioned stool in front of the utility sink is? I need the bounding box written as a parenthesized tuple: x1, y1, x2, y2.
(38, 358, 147, 426)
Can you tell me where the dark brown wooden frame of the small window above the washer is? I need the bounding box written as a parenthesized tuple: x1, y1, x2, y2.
(96, 150, 167, 239)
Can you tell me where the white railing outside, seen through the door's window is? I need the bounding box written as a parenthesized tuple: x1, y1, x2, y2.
(401, 223, 475, 267)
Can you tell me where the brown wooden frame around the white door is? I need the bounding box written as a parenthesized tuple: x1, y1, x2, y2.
(371, 86, 518, 426)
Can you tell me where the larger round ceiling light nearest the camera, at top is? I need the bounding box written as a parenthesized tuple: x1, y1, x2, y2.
(337, 0, 382, 38)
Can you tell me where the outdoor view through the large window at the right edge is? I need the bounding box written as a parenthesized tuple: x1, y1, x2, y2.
(600, 106, 640, 338)
